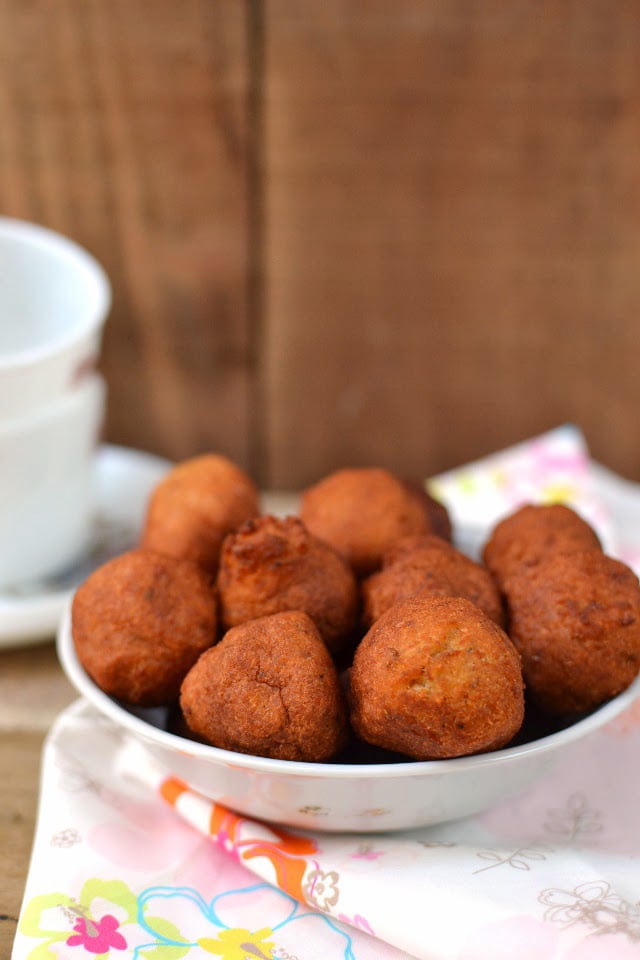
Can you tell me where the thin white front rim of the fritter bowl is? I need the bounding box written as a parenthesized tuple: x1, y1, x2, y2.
(56, 600, 640, 780)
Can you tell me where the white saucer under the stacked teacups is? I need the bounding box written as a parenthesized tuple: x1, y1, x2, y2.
(0, 445, 171, 648)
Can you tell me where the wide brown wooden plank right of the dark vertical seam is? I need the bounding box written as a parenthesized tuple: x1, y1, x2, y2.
(264, 0, 640, 486)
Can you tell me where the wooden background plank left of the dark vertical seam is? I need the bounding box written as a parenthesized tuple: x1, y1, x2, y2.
(0, 0, 251, 462)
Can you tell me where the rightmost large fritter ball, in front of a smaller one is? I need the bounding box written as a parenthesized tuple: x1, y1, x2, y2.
(506, 550, 640, 714)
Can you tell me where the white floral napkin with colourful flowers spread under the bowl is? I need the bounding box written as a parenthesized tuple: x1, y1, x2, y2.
(13, 428, 640, 960)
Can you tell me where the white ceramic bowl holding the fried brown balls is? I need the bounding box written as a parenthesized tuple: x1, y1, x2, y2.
(58, 611, 640, 833)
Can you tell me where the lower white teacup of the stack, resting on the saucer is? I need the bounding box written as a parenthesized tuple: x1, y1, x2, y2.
(0, 373, 106, 592)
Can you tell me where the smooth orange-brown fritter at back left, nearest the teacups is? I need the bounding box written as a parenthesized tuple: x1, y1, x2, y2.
(141, 454, 260, 575)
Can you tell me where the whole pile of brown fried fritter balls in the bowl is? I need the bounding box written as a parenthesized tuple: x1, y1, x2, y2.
(72, 455, 640, 762)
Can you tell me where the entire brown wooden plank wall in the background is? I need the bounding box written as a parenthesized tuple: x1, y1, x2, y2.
(0, 0, 640, 488)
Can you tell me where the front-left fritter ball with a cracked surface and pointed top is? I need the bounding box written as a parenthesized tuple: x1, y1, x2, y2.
(180, 611, 347, 762)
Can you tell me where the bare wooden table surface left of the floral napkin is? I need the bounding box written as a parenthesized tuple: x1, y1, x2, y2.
(0, 643, 77, 960)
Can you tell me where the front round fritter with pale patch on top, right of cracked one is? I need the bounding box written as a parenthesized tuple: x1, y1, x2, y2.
(350, 597, 524, 760)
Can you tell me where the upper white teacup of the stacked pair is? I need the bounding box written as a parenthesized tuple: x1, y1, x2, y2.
(0, 223, 111, 425)
